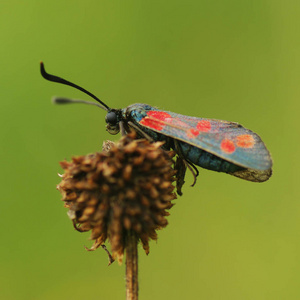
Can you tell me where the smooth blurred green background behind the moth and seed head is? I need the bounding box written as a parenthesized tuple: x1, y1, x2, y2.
(0, 0, 300, 300)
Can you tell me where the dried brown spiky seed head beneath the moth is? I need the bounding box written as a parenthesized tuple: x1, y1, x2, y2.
(58, 133, 176, 260)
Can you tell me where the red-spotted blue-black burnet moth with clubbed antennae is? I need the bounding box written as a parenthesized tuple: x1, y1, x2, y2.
(40, 63, 272, 188)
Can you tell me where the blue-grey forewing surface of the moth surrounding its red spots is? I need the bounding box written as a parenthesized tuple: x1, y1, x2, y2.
(124, 103, 272, 171)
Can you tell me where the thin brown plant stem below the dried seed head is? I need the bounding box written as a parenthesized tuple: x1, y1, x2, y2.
(126, 231, 138, 300)
